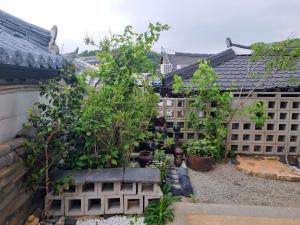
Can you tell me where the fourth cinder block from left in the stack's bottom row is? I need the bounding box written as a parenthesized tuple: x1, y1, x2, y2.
(104, 195, 124, 214)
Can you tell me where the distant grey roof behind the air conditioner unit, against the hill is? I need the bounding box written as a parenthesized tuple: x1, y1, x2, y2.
(163, 52, 213, 70)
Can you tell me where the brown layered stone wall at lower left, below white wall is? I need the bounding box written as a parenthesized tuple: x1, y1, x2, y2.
(0, 138, 36, 225)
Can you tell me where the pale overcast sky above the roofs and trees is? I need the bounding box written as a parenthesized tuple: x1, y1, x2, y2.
(0, 0, 300, 53)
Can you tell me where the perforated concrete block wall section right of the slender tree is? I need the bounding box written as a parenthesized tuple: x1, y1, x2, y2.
(227, 92, 300, 156)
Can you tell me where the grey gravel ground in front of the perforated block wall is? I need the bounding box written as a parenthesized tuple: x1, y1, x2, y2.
(189, 163, 300, 207)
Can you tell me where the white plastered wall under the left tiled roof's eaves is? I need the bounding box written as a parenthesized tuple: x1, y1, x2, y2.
(0, 85, 40, 144)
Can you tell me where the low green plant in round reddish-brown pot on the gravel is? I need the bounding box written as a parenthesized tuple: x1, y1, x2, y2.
(186, 138, 220, 172)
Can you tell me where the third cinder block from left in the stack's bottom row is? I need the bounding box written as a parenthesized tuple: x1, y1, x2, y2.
(84, 195, 104, 216)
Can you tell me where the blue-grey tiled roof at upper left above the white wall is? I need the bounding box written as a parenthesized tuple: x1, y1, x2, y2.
(0, 10, 63, 70)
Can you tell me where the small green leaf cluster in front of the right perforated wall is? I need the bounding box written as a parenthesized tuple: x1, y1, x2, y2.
(244, 101, 269, 128)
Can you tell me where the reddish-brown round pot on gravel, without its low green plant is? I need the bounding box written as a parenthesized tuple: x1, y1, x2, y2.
(186, 154, 213, 172)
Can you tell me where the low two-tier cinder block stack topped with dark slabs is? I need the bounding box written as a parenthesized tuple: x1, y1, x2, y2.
(46, 168, 162, 216)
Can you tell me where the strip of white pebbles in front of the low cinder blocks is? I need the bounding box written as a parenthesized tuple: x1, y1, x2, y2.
(76, 216, 145, 225)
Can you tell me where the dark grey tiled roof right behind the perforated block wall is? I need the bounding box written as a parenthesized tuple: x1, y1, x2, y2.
(164, 49, 300, 89)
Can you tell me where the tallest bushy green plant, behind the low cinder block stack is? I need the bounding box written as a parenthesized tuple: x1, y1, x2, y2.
(77, 23, 168, 167)
